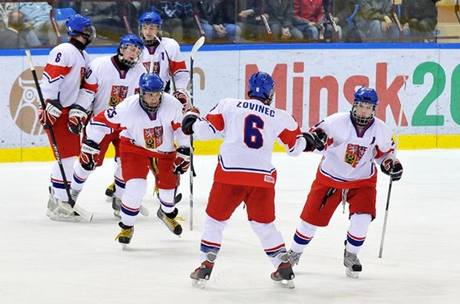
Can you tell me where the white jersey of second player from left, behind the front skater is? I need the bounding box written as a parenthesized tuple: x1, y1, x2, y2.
(78, 56, 146, 114)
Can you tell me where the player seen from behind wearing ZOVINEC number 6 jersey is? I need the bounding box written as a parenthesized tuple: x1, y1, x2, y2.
(182, 72, 321, 287)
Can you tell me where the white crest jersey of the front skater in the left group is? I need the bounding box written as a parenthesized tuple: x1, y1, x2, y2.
(86, 93, 190, 152)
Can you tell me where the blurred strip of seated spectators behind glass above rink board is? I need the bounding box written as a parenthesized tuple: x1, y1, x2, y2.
(0, 0, 460, 48)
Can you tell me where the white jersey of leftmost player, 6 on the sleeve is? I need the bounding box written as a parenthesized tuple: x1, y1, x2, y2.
(41, 42, 89, 107)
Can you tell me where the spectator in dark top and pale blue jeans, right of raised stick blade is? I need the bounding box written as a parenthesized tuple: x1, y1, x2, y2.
(211, 0, 241, 42)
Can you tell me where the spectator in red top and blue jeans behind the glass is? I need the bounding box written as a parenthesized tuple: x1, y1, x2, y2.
(294, 0, 342, 41)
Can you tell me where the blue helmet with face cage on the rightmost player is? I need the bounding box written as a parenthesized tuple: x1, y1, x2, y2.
(351, 87, 379, 127)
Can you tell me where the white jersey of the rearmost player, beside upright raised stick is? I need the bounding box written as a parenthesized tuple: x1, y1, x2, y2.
(142, 37, 190, 90)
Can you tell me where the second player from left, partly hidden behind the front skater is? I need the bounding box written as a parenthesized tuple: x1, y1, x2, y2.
(71, 34, 146, 216)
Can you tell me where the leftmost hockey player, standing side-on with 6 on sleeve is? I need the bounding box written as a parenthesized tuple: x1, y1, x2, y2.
(39, 14, 95, 219)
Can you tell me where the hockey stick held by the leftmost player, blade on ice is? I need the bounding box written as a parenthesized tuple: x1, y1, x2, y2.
(25, 49, 93, 222)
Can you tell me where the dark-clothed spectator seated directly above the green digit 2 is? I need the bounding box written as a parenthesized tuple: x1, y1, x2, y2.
(400, 0, 439, 41)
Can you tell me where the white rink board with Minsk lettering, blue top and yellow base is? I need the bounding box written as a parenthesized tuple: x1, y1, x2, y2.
(0, 44, 460, 161)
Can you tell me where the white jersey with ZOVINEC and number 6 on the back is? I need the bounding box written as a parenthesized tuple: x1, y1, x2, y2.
(193, 98, 305, 187)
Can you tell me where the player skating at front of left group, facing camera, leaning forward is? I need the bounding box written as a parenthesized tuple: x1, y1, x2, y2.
(81, 73, 190, 244)
